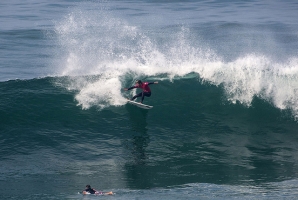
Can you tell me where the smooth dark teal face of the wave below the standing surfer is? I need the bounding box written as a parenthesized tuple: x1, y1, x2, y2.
(0, 77, 298, 188)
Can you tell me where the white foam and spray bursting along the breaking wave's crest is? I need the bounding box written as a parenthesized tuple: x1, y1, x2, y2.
(56, 6, 298, 117)
